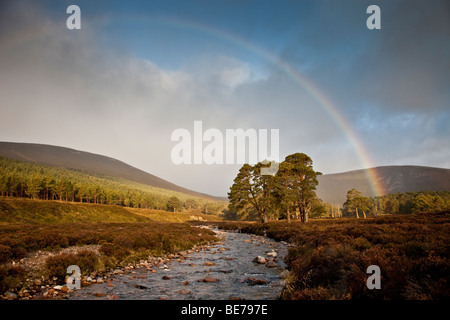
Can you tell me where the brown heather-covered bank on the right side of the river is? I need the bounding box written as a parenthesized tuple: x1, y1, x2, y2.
(216, 213, 450, 300)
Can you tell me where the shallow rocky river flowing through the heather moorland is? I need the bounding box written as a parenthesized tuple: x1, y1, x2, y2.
(67, 229, 287, 300)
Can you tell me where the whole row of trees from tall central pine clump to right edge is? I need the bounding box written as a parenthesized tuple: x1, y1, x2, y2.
(229, 153, 450, 223)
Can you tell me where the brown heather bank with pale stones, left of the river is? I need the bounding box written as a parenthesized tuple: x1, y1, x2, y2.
(0, 222, 216, 299)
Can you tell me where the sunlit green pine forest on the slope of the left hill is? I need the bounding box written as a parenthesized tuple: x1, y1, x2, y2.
(0, 157, 225, 214)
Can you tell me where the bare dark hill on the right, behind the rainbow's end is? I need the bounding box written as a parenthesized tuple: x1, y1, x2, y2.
(317, 166, 450, 205)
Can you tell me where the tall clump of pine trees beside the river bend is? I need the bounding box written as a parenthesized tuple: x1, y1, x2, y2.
(227, 153, 323, 222)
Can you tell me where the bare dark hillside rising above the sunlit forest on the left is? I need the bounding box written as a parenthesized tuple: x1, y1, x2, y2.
(0, 142, 226, 201)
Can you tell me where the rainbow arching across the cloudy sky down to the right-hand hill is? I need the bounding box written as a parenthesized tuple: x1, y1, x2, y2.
(0, 15, 387, 196)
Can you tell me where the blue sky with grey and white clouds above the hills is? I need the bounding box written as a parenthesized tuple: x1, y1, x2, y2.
(0, 0, 450, 196)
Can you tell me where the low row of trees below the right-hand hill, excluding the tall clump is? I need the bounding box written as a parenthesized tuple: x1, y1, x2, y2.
(343, 189, 450, 218)
